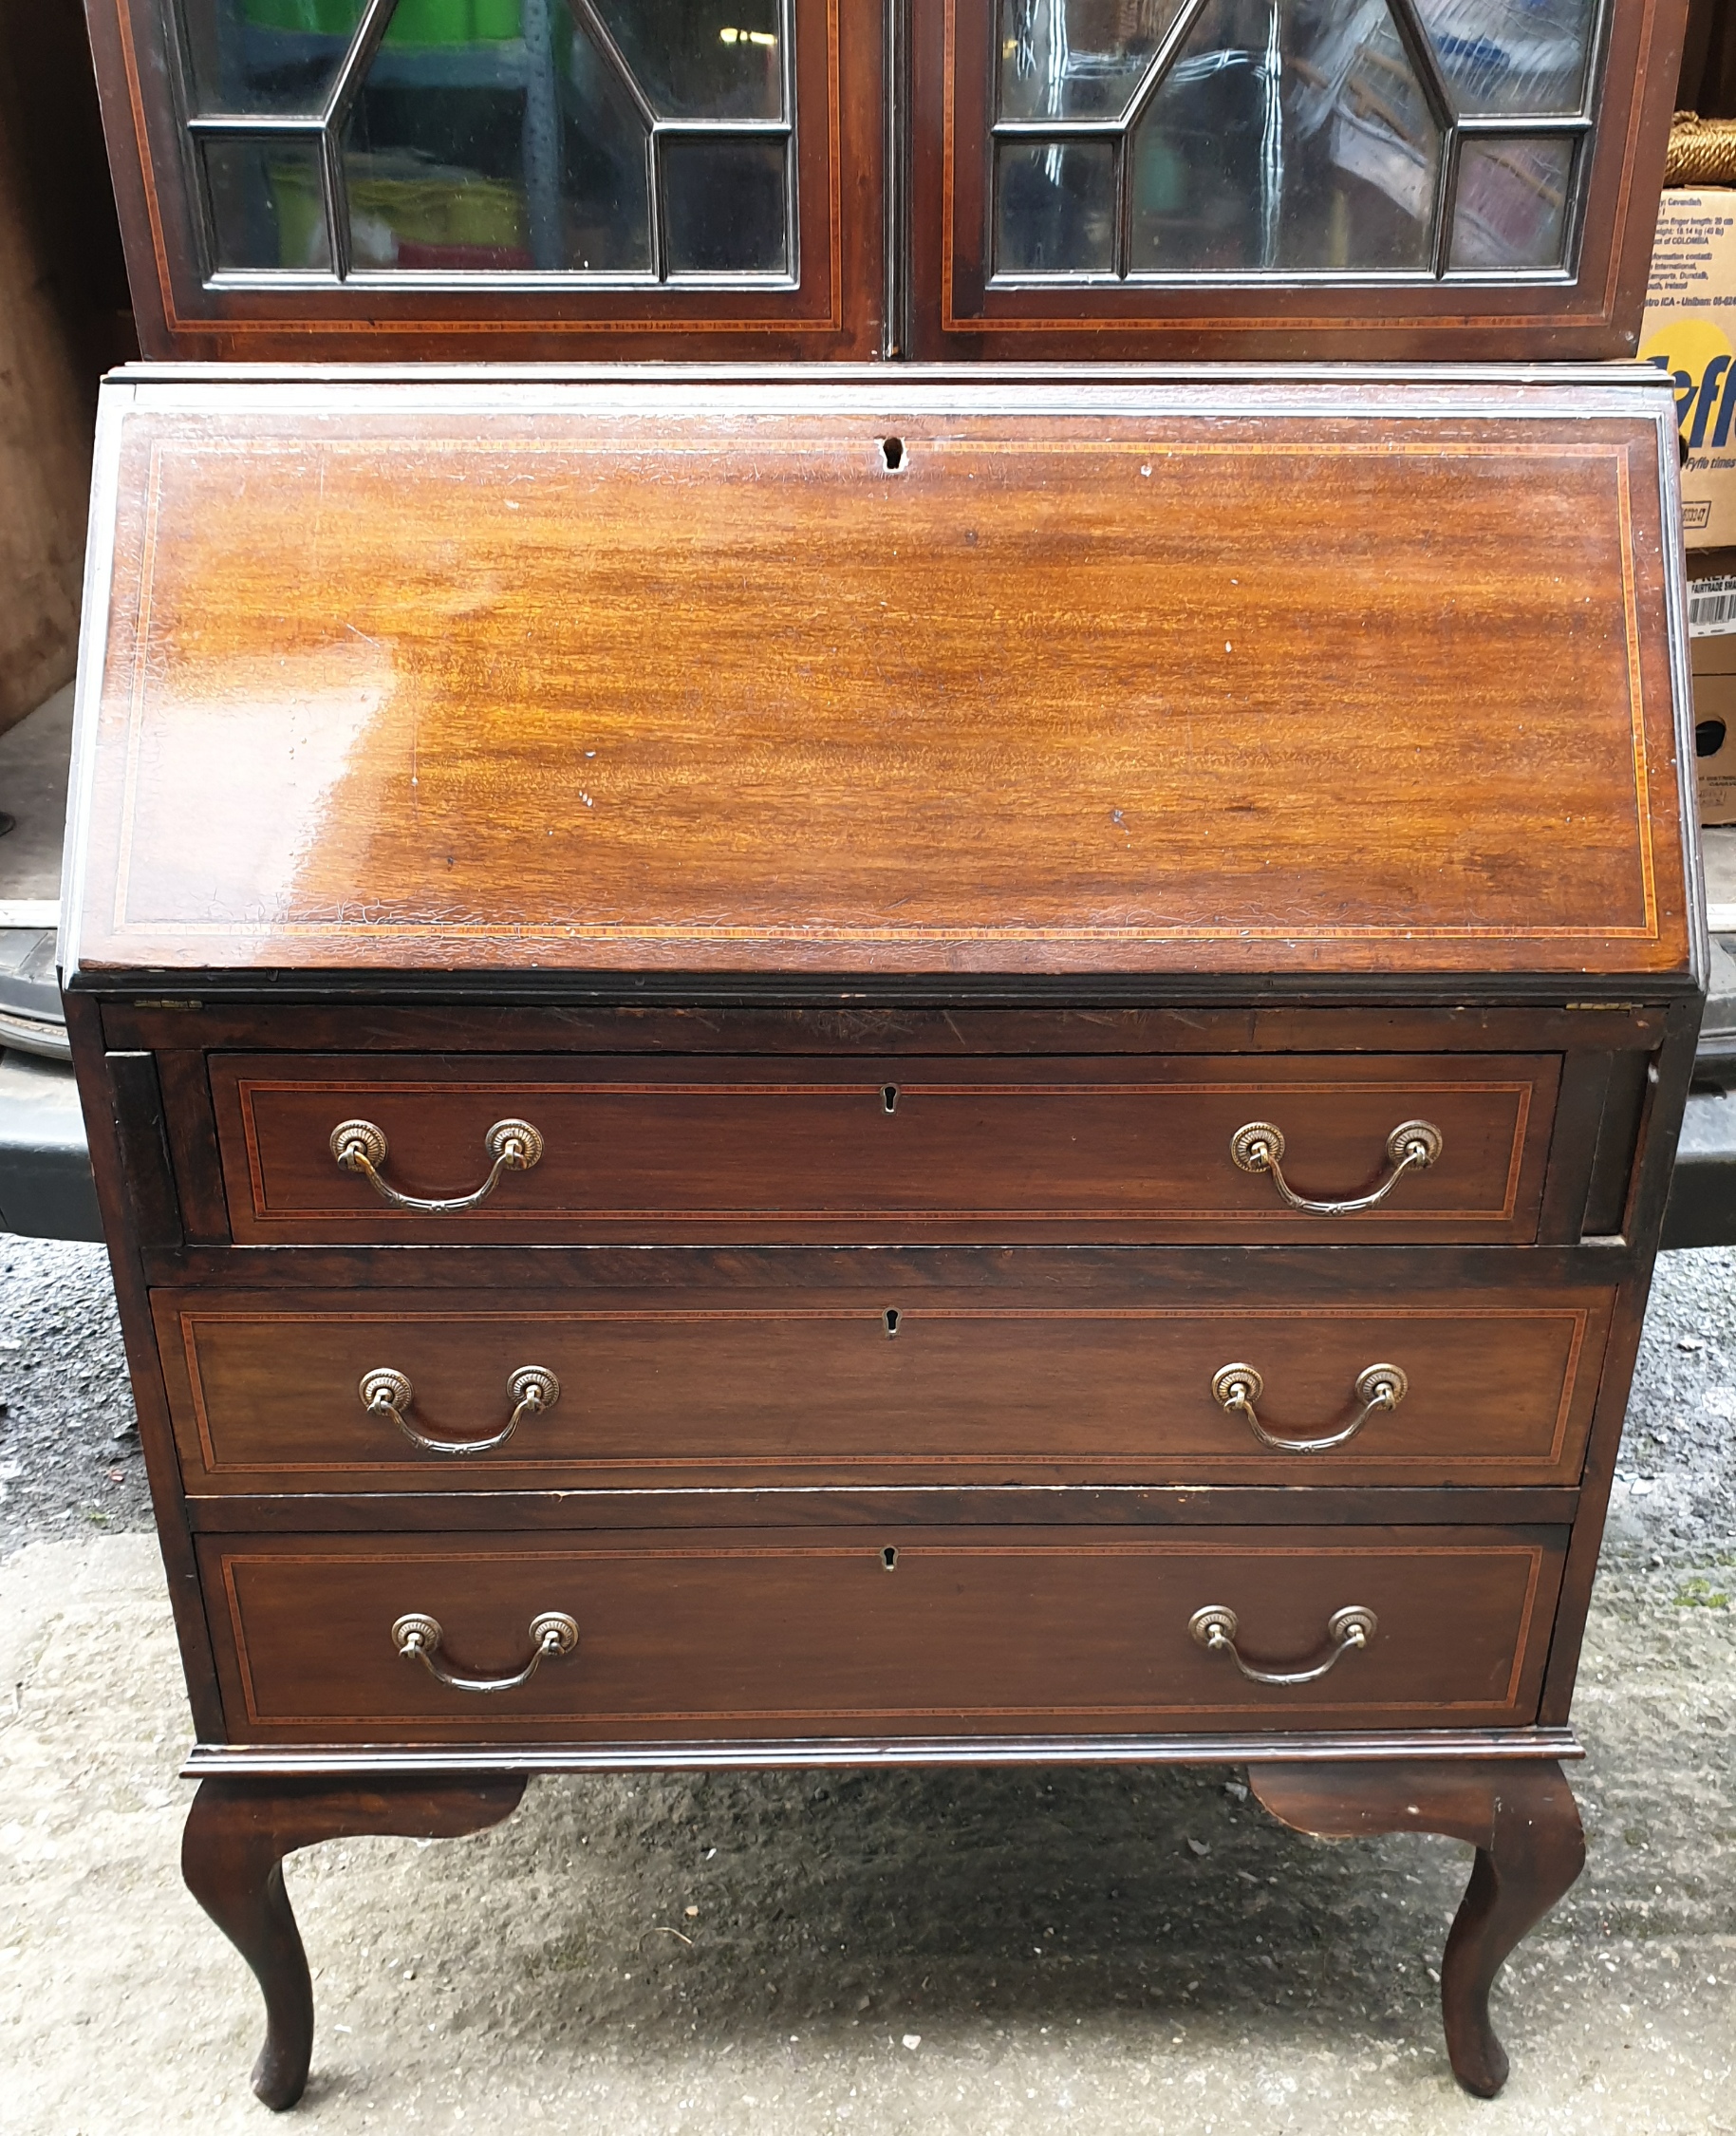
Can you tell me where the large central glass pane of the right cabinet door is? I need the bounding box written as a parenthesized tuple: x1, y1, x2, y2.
(1128, 0, 1442, 273)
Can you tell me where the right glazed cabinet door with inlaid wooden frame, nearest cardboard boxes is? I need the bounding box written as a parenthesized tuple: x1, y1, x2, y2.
(912, 0, 1683, 359)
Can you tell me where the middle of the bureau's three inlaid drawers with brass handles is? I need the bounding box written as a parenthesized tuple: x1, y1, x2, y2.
(154, 1282, 1613, 1493)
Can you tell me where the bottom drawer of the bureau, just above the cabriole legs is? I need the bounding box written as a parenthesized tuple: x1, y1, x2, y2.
(200, 1527, 1565, 1743)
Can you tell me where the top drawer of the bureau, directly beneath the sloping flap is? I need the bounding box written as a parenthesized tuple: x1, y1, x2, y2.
(212, 1053, 1559, 1244)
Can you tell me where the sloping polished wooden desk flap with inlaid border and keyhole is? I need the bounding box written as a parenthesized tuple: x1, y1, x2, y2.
(68, 372, 1691, 974)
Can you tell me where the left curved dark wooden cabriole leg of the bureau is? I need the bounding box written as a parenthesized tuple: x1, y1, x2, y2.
(181, 1775, 525, 2110)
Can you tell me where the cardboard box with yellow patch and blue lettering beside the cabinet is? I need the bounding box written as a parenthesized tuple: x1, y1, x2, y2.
(1640, 190, 1736, 549)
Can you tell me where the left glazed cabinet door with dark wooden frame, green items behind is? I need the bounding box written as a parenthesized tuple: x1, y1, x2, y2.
(89, 0, 884, 361)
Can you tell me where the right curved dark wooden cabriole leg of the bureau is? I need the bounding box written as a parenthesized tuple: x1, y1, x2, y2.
(1247, 1758, 1584, 2100)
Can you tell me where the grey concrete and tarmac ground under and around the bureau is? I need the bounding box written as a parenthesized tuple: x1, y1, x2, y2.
(0, 1241, 1736, 2136)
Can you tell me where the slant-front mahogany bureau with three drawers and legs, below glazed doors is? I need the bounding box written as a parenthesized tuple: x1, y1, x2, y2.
(66, 367, 1704, 2107)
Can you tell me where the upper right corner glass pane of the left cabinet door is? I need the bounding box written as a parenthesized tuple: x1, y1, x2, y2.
(596, 0, 786, 120)
